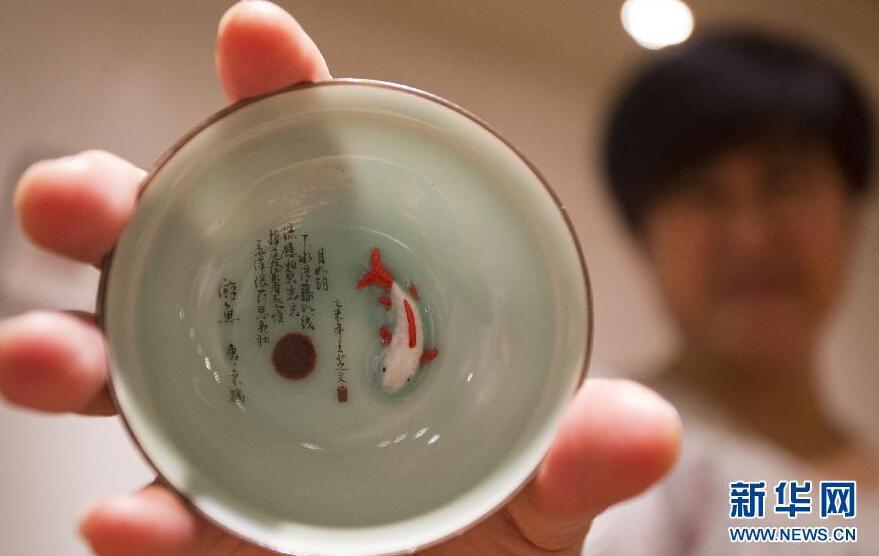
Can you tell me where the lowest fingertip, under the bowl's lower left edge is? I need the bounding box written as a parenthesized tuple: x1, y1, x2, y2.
(79, 483, 268, 556)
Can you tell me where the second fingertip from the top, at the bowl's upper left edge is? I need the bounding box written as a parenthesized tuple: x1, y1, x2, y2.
(15, 151, 144, 265)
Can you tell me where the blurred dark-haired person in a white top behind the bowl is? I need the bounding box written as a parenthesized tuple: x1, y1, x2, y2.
(587, 29, 879, 556)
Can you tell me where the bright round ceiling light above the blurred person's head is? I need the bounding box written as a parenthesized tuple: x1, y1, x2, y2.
(620, 0, 693, 50)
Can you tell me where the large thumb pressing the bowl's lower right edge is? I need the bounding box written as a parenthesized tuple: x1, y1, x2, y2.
(507, 379, 681, 550)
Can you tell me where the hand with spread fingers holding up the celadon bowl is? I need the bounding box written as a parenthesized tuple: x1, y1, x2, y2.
(0, 0, 680, 556)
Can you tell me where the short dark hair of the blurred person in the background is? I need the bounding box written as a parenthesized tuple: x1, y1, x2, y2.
(604, 30, 873, 232)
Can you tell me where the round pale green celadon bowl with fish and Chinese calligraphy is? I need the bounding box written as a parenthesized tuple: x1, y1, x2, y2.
(98, 79, 592, 556)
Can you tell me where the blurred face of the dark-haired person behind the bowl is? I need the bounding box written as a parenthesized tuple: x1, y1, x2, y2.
(643, 141, 853, 367)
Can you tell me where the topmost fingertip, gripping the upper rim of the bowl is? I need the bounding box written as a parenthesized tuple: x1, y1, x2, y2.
(215, 0, 330, 102)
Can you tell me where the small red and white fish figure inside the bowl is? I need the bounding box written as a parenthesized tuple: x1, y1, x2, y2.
(357, 248, 439, 392)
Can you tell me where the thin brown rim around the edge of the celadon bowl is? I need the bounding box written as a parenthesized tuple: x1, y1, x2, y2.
(95, 77, 594, 556)
